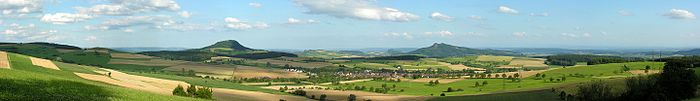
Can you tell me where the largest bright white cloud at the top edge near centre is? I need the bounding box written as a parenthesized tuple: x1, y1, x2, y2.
(292, 0, 420, 22)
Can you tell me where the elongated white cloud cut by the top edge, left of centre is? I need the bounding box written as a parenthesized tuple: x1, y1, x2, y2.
(76, 0, 180, 15)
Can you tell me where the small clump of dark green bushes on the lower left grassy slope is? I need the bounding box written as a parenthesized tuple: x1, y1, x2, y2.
(173, 85, 214, 99)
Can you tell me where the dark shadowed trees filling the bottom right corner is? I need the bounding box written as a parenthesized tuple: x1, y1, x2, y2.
(575, 58, 700, 101)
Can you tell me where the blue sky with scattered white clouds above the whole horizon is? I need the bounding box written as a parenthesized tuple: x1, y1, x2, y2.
(0, 0, 700, 49)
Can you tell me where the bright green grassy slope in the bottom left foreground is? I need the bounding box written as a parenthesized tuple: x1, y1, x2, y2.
(0, 53, 202, 101)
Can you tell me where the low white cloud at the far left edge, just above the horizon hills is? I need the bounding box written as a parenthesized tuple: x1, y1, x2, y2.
(0, 23, 64, 41)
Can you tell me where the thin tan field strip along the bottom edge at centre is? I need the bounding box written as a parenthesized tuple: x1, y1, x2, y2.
(304, 89, 430, 101)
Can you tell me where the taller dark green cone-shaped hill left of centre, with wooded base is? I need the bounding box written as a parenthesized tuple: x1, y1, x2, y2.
(139, 40, 297, 61)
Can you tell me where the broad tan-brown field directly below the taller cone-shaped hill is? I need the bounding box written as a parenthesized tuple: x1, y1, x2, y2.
(164, 63, 307, 78)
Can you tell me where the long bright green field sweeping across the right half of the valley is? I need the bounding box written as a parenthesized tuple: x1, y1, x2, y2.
(333, 62, 663, 96)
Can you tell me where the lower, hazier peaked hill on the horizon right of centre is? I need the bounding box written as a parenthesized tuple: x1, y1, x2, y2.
(409, 43, 518, 57)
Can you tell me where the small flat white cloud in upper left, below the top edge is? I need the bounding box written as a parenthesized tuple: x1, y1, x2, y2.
(41, 13, 93, 24)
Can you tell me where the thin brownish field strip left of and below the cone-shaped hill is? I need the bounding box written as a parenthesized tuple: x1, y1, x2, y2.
(109, 59, 187, 66)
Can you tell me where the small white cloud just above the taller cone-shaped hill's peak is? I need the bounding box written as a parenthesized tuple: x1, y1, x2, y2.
(224, 17, 270, 30)
